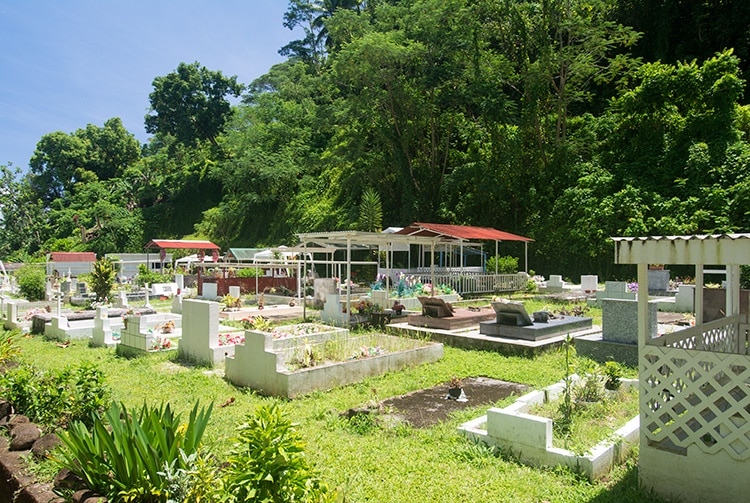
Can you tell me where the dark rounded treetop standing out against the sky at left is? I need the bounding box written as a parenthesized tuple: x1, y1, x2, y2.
(146, 61, 242, 145)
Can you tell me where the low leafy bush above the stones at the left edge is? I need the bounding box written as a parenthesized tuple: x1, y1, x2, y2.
(0, 363, 110, 427)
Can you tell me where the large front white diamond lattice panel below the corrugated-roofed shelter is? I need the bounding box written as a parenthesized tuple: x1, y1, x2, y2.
(640, 345, 750, 461)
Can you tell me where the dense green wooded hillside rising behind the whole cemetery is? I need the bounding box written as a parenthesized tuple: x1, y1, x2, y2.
(0, 0, 750, 277)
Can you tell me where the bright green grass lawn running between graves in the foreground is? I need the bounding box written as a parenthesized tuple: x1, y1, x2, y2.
(5, 308, 659, 503)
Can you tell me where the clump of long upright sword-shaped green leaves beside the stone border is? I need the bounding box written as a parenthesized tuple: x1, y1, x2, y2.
(54, 402, 213, 502)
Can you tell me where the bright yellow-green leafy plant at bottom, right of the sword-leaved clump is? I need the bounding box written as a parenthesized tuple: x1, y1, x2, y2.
(222, 404, 335, 503)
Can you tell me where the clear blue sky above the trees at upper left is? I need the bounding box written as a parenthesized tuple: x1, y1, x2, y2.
(0, 0, 300, 170)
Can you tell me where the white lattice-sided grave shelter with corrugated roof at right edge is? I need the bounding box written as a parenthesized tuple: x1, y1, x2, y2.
(614, 234, 750, 502)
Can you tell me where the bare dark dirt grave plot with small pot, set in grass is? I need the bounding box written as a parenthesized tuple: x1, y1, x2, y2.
(381, 377, 527, 428)
